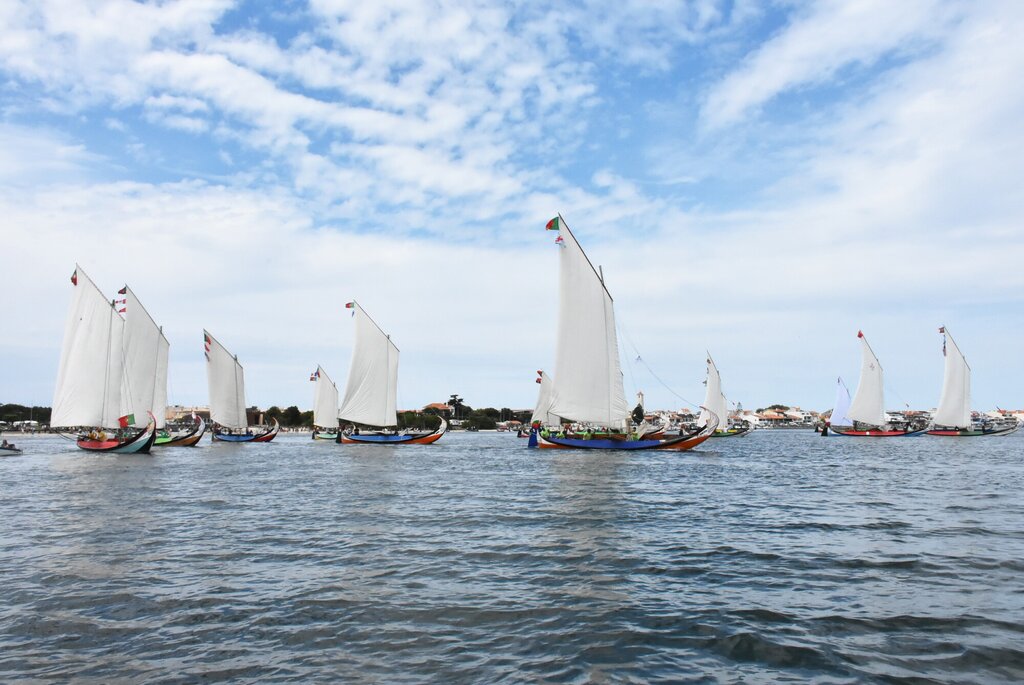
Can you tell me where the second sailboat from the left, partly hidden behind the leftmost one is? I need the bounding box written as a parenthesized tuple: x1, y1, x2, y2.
(116, 286, 206, 447)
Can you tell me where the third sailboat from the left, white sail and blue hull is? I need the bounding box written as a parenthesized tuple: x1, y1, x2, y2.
(203, 330, 281, 442)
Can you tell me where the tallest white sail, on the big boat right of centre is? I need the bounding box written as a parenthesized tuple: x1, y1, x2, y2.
(550, 217, 630, 428)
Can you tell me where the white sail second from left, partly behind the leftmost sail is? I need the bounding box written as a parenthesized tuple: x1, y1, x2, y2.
(124, 286, 170, 428)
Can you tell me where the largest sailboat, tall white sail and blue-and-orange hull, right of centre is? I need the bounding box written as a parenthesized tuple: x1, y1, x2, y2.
(529, 215, 719, 449)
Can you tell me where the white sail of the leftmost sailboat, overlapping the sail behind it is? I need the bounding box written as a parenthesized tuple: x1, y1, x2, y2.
(50, 265, 124, 428)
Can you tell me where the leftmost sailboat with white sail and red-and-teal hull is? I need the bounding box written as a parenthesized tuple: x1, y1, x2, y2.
(50, 264, 157, 454)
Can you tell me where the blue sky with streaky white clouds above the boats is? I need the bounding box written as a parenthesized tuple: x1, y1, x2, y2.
(0, 0, 1024, 410)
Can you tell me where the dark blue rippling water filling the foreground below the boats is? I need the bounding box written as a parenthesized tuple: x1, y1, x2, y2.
(0, 431, 1024, 683)
